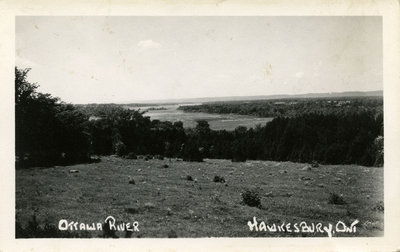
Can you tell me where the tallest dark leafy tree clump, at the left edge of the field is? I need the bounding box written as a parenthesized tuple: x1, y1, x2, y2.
(15, 68, 89, 167)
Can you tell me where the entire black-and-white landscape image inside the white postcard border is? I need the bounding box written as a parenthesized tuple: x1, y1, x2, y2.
(0, 0, 398, 250)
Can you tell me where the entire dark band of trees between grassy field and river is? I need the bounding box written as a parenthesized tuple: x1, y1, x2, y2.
(15, 68, 383, 167)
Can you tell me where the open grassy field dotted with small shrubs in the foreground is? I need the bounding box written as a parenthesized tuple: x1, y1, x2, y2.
(16, 156, 384, 237)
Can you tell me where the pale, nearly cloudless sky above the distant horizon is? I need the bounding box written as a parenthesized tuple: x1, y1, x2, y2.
(15, 16, 383, 103)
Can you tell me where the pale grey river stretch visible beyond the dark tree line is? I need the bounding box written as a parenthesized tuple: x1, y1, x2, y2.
(126, 104, 273, 130)
